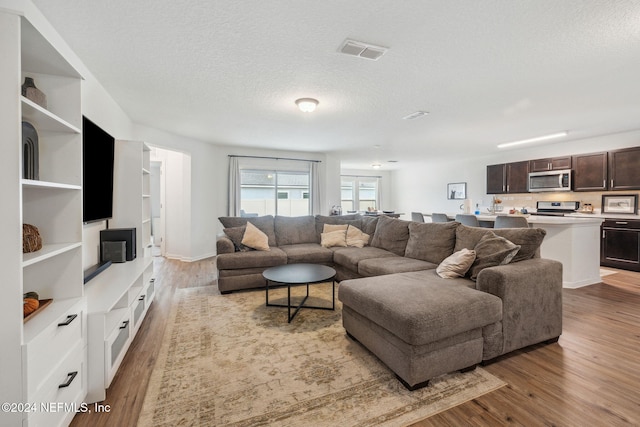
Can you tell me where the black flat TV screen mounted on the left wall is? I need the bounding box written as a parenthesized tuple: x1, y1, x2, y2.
(82, 116, 115, 222)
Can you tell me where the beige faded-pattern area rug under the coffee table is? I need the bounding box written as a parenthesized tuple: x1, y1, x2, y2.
(138, 284, 505, 427)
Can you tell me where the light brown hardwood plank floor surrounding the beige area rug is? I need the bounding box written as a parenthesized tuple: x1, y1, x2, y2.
(72, 257, 640, 427)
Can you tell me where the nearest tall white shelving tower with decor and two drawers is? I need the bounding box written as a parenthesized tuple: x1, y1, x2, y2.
(0, 9, 87, 426)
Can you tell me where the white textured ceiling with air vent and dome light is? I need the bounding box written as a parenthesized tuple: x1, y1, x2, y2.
(34, 0, 640, 169)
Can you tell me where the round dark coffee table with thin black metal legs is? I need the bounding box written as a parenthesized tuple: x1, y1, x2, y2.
(262, 264, 336, 323)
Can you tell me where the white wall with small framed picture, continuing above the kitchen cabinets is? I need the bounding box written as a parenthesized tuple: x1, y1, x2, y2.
(391, 131, 640, 217)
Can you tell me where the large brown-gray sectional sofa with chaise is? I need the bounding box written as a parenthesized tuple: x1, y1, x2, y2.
(217, 215, 562, 389)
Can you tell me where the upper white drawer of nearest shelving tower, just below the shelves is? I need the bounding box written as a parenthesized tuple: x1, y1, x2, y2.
(22, 300, 86, 397)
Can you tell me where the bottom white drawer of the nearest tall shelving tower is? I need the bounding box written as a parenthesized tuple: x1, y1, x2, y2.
(26, 343, 87, 427)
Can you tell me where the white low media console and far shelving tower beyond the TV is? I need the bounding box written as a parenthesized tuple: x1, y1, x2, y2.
(85, 140, 155, 403)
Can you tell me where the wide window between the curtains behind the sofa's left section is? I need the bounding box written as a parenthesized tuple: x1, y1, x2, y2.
(240, 169, 311, 216)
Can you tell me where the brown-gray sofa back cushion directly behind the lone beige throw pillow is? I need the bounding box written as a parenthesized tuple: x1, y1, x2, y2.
(404, 221, 459, 264)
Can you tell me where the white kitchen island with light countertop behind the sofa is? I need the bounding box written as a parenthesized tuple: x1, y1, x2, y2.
(424, 213, 604, 288)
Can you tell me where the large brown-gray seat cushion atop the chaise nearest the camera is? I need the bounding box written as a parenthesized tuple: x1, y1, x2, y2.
(338, 270, 502, 345)
